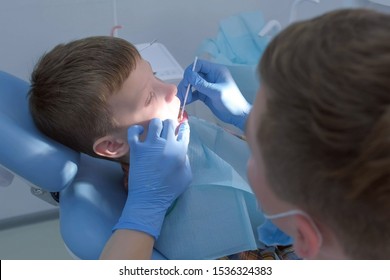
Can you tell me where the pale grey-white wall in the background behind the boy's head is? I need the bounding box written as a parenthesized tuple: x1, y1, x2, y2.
(0, 0, 384, 80)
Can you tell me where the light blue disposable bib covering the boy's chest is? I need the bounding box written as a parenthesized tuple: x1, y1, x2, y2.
(155, 117, 290, 259)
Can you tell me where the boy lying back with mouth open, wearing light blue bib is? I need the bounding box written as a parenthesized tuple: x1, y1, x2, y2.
(29, 36, 294, 259)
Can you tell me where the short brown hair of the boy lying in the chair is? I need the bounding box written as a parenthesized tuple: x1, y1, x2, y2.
(29, 36, 140, 156)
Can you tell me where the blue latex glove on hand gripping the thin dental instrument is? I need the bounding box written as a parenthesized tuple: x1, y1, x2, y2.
(177, 60, 251, 131)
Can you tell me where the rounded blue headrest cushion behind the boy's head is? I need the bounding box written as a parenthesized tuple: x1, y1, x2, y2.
(0, 71, 80, 192)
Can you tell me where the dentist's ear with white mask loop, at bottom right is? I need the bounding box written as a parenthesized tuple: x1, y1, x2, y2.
(294, 215, 322, 259)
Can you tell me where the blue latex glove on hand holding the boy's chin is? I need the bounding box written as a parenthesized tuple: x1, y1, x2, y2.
(114, 119, 192, 239)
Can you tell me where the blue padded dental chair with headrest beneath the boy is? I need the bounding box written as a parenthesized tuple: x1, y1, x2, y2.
(0, 71, 164, 259)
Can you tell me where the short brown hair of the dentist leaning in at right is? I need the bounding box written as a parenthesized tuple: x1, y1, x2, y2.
(256, 9, 390, 259)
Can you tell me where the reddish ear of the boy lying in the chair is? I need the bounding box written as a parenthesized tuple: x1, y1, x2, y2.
(93, 135, 129, 158)
